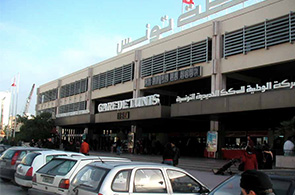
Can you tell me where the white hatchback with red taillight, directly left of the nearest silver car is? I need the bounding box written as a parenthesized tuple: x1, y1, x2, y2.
(32, 156, 131, 194)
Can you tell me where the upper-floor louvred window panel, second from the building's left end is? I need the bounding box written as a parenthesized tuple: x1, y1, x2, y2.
(60, 78, 88, 98)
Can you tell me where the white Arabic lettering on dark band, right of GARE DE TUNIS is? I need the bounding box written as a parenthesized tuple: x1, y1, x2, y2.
(176, 79, 295, 103)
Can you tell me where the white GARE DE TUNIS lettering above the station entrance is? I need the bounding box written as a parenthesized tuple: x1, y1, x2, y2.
(98, 94, 160, 112)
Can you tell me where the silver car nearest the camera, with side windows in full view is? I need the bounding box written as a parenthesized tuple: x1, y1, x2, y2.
(69, 162, 209, 195)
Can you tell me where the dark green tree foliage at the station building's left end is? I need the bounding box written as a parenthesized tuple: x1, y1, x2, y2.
(17, 112, 54, 141)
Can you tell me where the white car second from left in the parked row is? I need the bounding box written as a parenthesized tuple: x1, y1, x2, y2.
(14, 150, 84, 190)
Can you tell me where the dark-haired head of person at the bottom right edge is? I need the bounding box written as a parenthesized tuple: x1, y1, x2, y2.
(240, 170, 275, 195)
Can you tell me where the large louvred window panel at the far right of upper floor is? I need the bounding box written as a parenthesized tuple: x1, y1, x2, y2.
(223, 12, 295, 57)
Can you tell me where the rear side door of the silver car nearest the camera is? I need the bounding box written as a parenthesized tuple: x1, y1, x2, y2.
(130, 168, 169, 195)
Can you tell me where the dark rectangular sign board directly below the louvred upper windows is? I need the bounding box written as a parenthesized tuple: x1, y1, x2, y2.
(144, 66, 202, 87)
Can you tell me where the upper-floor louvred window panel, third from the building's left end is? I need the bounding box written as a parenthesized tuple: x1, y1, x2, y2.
(92, 63, 134, 90)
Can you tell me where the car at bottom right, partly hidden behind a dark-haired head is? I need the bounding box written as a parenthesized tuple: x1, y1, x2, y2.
(209, 169, 295, 195)
